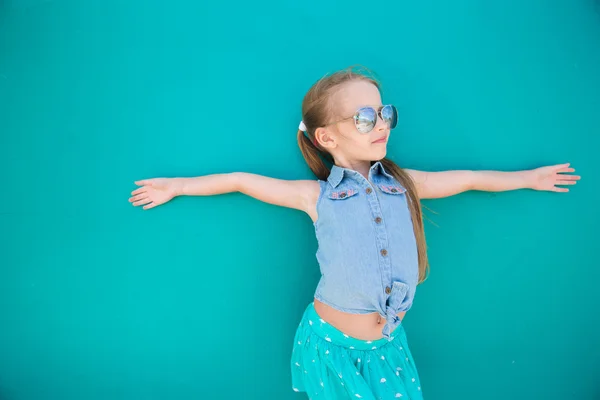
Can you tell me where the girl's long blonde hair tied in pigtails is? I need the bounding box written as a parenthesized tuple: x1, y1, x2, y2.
(298, 67, 429, 283)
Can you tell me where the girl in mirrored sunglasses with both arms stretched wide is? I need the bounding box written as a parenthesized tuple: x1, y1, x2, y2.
(129, 69, 579, 400)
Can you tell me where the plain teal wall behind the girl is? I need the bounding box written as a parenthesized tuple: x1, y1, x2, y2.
(0, 0, 600, 400)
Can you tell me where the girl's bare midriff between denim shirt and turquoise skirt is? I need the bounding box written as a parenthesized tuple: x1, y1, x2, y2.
(314, 299, 406, 340)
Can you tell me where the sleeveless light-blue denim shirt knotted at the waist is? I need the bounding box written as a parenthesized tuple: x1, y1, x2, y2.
(314, 162, 419, 340)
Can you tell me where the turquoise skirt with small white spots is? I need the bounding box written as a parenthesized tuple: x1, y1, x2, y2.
(291, 303, 423, 400)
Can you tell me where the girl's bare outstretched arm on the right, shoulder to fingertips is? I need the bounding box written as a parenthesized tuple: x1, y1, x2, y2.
(406, 164, 581, 199)
